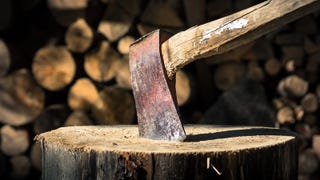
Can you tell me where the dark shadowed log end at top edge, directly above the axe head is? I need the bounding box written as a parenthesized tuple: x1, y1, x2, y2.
(141, 0, 184, 28)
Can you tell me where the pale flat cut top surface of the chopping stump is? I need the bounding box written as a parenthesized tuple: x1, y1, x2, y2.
(36, 125, 295, 153)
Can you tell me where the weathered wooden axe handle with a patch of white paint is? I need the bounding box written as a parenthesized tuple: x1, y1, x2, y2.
(161, 0, 320, 78)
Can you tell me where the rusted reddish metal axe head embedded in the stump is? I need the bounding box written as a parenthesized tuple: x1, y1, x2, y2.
(129, 30, 186, 141)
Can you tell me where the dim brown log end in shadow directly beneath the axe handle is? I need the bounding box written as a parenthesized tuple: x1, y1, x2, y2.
(213, 62, 246, 91)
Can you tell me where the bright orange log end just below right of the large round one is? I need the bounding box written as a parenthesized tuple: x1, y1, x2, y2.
(68, 78, 99, 111)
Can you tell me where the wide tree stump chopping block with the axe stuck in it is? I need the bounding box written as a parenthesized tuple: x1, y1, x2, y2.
(36, 125, 298, 180)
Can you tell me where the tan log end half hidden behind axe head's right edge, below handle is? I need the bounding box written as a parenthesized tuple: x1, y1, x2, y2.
(176, 70, 191, 106)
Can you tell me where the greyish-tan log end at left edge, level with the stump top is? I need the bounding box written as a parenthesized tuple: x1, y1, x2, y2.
(1, 125, 30, 156)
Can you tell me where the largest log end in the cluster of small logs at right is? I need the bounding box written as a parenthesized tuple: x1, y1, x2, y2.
(278, 75, 309, 97)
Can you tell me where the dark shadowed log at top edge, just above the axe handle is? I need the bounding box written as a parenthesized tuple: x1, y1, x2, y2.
(183, 0, 205, 27)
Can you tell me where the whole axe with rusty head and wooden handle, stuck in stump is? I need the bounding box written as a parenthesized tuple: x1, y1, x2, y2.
(129, 0, 320, 141)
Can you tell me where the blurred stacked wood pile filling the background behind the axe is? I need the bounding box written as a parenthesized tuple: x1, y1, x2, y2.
(0, 0, 320, 179)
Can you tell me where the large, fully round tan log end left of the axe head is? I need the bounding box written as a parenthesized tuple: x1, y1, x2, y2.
(32, 46, 76, 91)
